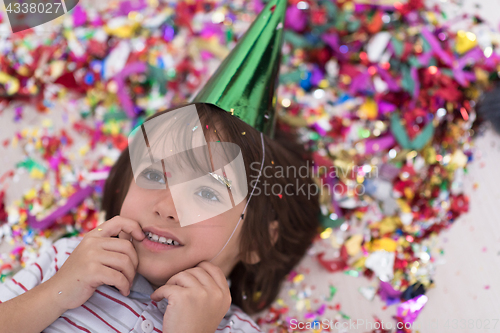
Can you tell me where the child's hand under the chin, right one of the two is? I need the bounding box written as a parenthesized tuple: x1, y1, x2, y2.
(151, 261, 231, 333)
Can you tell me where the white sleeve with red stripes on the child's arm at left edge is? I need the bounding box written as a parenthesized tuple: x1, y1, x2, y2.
(0, 237, 82, 303)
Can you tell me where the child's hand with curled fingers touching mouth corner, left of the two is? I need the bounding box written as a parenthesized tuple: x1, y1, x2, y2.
(47, 216, 145, 309)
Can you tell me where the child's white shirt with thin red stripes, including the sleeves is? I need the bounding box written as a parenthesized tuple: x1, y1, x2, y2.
(0, 237, 262, 333)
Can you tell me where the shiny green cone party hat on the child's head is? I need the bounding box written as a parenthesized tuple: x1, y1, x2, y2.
(192, 0, 287, 137)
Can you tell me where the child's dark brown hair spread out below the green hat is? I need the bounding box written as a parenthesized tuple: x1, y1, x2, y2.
(102, 103, 319, 314)
